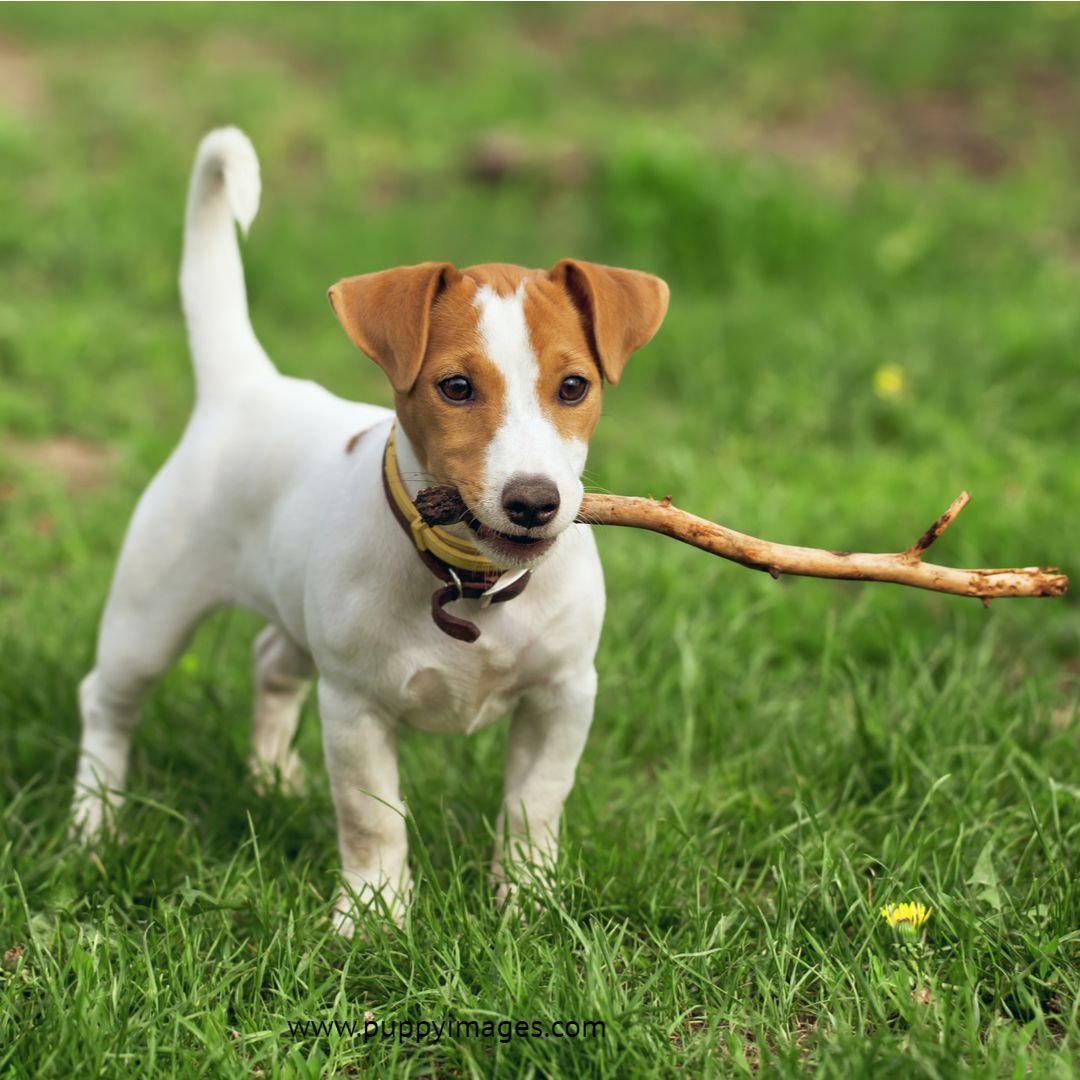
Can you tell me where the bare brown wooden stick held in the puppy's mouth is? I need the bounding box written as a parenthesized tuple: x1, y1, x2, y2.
(416, 486, 1069, 605)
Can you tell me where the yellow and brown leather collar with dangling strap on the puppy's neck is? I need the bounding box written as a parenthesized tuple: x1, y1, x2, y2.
(382, 424, 531, 643)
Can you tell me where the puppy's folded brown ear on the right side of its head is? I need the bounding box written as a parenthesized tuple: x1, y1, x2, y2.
(549, 259, 670, 382)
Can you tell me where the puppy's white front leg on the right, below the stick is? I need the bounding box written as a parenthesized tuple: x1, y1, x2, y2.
(491, 667, 596, 906)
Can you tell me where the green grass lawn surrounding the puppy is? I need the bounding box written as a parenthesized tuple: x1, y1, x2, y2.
(0, 4, 1080, 1078)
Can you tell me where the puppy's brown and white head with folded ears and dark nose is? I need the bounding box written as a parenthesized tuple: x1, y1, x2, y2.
(329, 259, 667, 566)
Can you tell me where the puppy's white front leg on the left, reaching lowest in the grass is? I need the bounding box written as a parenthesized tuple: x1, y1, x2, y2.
(319, 679, 411, 936)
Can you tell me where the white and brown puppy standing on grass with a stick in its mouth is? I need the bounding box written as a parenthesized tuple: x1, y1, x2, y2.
(72, 127, 669, 935)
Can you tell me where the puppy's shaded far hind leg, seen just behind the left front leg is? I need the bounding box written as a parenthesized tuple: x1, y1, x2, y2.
(251, 624, 315, 792)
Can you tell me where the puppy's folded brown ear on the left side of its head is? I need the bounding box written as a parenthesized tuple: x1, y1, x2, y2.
(329, 262, 461, 394)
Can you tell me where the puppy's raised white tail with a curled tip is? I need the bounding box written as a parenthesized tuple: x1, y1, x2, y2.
(180, 127, 273, 396)
